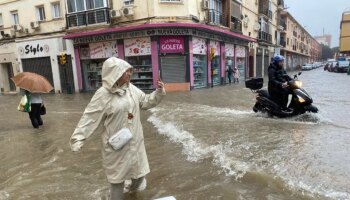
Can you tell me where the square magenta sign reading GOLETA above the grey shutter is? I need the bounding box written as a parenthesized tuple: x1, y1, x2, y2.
(160, 36, 185, 53)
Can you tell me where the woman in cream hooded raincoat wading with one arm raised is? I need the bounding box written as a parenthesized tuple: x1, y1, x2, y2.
(70, 57, 165, 200)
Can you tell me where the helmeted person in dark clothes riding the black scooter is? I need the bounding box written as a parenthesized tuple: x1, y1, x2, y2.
(268, 55, 293, 112)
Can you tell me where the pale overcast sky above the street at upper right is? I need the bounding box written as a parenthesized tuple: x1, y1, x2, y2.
(285, 0, 350, 47)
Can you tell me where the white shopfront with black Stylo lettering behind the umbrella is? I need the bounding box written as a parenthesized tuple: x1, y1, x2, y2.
(16, 37, 77, 93)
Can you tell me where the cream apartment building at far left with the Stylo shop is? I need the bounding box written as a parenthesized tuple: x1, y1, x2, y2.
(0, 0, 78, 92)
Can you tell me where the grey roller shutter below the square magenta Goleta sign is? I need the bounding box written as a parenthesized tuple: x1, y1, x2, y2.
(160, 56, 186, 83)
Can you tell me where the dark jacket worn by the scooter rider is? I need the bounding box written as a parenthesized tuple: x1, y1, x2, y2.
(269, 63, 292, 90)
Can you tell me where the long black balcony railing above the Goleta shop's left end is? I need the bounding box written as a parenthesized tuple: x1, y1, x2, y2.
(66, 8, 110, 28)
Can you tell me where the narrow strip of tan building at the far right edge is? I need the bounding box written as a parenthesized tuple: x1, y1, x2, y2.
(339, 11, 350, 57)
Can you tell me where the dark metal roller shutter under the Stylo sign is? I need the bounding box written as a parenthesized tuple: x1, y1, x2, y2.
(22, 57, 53, 86)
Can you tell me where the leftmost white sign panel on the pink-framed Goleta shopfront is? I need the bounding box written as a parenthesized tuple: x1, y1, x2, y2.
(89, 42, 118, 59)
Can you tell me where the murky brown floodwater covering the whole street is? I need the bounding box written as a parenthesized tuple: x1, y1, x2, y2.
(0, 69, 350, 200)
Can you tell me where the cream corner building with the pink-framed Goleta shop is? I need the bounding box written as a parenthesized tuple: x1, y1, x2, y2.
(65, 0, 256, 91)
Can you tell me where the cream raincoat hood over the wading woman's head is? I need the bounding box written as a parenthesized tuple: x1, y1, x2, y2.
(102, 57, 132, 92)
